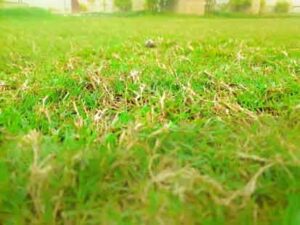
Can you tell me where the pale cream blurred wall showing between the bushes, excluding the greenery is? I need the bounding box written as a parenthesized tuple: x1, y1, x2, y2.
(2, 0, 300, 15)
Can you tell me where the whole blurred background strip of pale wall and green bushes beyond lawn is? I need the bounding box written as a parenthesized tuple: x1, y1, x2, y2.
(0, 0, 300, 15)
